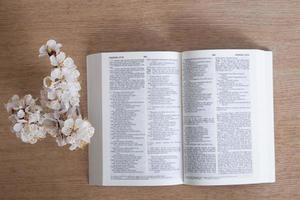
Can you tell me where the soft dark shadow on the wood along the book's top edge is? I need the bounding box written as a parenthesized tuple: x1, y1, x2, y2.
(87, 19, 268, 54)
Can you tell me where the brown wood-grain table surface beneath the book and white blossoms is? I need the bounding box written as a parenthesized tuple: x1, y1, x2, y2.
(0, 0, 300, 200)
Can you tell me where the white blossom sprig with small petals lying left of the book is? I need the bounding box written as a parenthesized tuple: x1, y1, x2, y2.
(5, 40, 95, 150)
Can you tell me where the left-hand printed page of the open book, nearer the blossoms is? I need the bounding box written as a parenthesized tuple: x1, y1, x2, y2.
(101, 52, 183, 186)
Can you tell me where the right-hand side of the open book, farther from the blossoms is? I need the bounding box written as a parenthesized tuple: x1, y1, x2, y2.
(182, 50, 275, 185)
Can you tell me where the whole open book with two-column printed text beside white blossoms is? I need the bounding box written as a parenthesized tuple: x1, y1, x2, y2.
(87, 49, 275, 186)
